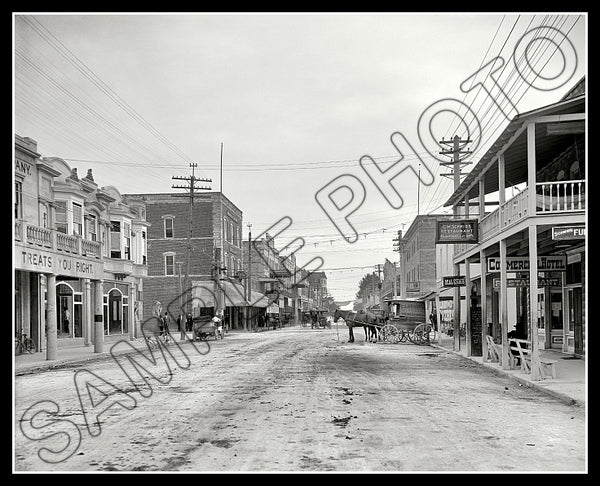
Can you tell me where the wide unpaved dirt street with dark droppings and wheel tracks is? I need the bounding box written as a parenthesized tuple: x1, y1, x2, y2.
(14, 326, 586, 472)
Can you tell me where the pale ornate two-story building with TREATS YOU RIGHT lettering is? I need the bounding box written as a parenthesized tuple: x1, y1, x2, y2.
(13, 135, 148, 359)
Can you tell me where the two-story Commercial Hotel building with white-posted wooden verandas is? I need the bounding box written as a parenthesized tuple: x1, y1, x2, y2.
(446, 79, 587, 379)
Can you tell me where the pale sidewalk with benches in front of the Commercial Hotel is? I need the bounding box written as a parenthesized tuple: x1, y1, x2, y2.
(432, 334, 587, 406)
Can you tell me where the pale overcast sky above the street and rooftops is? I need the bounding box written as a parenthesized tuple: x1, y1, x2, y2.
(13, 12, 588, 300)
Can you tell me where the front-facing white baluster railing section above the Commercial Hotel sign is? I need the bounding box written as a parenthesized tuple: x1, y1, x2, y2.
(535, 180, 585, 214)
